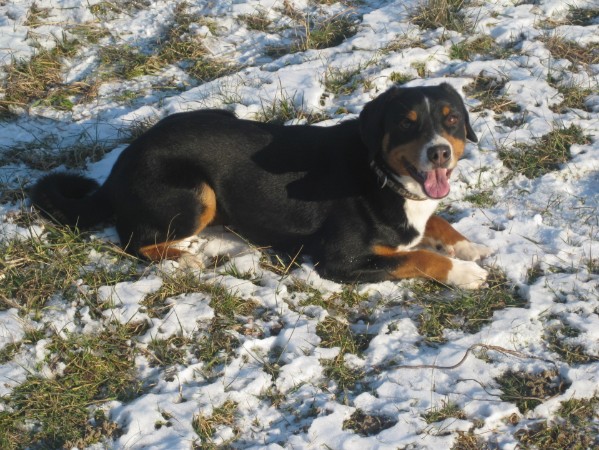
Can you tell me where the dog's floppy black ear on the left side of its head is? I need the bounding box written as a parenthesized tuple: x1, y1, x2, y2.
(360, 86, 400, 160)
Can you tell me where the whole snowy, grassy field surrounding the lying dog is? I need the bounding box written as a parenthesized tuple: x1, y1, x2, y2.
(0, 0, 599, 450)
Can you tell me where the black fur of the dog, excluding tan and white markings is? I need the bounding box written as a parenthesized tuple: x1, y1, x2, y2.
(31, 85, 476, 281)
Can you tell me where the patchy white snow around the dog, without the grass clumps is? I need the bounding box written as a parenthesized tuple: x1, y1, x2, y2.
(0, 0, 599, 449)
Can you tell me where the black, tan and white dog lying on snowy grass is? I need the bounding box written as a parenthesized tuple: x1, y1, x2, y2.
(31, 84, 489, 288)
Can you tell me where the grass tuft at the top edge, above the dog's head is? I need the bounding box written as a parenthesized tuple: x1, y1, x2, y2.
(412, 0, 468, 33)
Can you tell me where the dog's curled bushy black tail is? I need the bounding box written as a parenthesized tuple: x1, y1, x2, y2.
(30, 173, 113, 228)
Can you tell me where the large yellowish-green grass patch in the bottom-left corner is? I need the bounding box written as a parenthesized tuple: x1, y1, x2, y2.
(0, 326, 140, 449)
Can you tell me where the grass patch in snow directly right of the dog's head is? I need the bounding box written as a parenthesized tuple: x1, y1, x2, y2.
(499, 125, 590, 178)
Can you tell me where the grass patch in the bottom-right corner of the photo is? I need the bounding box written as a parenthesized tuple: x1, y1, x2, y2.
(515, 396, 599, 450)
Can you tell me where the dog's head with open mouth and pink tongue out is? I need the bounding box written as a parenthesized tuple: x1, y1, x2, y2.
(360, 83, 478, 199)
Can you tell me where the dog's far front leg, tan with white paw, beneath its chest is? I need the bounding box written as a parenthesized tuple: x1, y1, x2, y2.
(421, 216, 492, 261)
